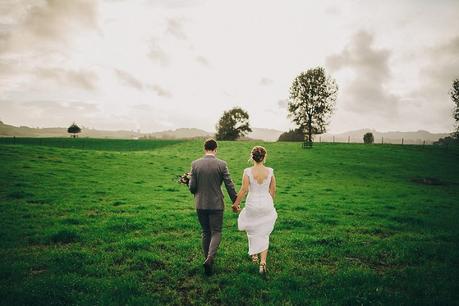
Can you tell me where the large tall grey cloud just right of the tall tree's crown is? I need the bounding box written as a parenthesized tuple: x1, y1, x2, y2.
(326, 31, 400, 119)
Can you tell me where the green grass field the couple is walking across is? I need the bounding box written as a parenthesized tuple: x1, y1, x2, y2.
(0, 139, 459, 305)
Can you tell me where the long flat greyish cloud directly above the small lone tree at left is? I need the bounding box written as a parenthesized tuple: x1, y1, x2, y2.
(34, 68, 98, 91)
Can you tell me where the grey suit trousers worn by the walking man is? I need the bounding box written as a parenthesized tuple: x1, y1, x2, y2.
(196, 209, 223, 258)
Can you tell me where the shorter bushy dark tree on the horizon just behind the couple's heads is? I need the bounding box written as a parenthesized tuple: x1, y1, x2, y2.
(215, 107, 252, 140)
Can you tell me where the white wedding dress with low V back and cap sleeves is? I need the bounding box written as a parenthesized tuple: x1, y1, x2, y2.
(237, 168, 277, 255)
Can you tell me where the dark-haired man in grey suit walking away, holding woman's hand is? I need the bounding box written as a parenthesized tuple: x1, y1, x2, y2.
(188, 139, 237, 275)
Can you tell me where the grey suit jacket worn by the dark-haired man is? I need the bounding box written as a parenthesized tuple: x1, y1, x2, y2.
(188, 155, 237, 209)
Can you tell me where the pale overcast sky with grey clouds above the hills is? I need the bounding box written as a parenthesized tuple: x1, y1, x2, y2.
(0, 0, 459, 133)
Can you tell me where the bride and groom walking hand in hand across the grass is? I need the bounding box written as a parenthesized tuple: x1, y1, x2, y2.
(188, 139, 277, 275)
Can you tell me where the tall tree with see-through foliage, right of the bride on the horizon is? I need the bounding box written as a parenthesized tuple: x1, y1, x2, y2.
(288, 67, 338, 145)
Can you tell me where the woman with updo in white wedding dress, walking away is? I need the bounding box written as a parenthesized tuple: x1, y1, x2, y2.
(232, 146, 277, 274)
